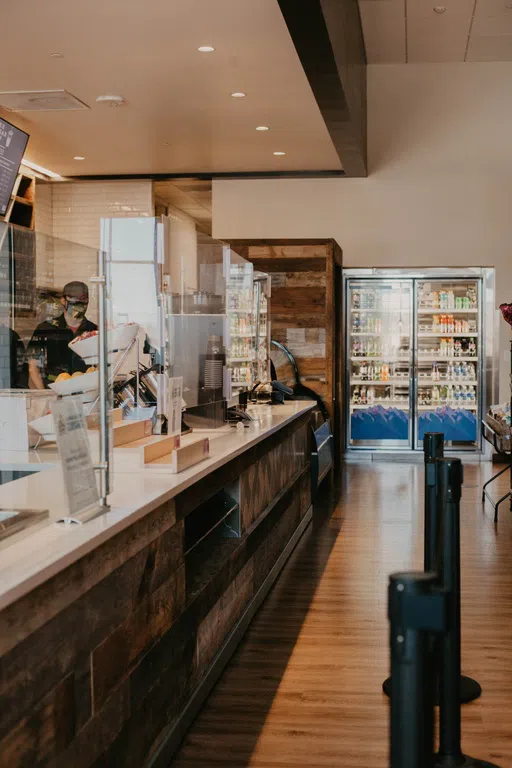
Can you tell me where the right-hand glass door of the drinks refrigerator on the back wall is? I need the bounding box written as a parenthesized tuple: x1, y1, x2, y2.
(416, 278, 482, 450)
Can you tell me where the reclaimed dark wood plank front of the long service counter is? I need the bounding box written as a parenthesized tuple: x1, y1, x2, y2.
(0, 411, 311, 768)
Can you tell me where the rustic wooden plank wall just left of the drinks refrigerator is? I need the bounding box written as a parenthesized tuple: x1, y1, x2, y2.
(230, 240, 342, 420)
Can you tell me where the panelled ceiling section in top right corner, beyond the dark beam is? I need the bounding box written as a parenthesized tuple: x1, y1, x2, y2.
(359, 0, 512, 64)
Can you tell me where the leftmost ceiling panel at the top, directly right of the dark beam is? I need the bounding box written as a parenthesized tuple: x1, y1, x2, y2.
(359, 0, 405, 64)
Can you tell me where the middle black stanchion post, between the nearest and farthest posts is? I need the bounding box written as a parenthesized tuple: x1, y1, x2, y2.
(434, 459, 496, 768)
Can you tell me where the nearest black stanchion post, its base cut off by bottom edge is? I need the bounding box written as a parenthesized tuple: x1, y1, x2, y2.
(388, 572, 445, 768)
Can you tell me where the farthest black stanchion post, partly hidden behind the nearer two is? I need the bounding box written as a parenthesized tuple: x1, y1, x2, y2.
(382, 432, 482, 704)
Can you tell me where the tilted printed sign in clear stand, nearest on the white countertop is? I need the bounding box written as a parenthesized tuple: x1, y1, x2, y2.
(52, 397, 99, 516)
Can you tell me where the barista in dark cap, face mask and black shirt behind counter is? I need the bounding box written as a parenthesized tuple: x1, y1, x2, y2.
(27, 280, 98, 389)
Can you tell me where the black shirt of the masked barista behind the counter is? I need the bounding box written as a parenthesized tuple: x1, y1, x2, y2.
(27, 313, 98, 387)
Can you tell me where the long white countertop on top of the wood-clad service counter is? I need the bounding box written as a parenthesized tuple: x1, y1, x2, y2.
(0, 401, 315, 610)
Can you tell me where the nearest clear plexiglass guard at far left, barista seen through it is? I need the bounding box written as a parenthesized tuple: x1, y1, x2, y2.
(0, 223, 112, 532)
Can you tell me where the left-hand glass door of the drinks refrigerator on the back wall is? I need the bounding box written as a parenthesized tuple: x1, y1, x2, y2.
(347, 278, 413, 449)
